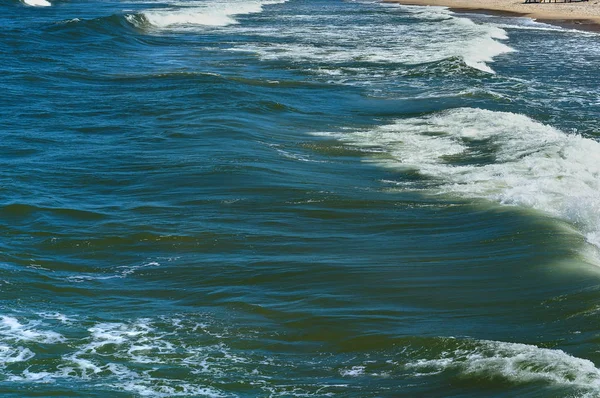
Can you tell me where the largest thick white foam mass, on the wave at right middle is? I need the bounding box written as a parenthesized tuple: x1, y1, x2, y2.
(314, 108, 600, 247)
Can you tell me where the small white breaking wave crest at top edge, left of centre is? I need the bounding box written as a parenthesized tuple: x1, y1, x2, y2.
(137, 0, 287, 29)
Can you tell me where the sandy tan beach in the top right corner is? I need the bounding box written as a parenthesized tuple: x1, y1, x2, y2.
(383, 0, 600, 32)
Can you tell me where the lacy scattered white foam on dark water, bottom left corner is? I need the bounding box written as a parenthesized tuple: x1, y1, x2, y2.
(0, 313, 232, 397)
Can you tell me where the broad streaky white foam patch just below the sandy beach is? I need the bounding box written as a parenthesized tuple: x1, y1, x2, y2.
(231, 6, 514, 75)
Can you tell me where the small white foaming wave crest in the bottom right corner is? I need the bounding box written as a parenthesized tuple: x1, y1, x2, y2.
(405, 340, 600, 393)
